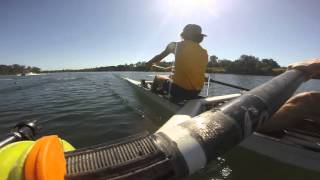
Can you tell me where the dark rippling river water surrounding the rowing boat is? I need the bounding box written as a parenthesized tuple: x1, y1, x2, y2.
(0, 72, 320, 180)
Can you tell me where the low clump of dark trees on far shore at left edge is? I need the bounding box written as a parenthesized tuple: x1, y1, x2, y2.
(0, 64, 41, 75)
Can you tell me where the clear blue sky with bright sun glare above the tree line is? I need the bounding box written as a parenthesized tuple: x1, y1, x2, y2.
(0, 0, 320, 70)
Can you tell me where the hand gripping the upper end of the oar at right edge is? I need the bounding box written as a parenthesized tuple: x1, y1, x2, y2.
(288, 58, 320, 80)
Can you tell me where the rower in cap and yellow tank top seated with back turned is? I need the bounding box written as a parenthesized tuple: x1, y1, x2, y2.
(147, 24, 208, 101)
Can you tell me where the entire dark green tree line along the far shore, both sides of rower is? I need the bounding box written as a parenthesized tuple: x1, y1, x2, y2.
(0, 55, 286, 75)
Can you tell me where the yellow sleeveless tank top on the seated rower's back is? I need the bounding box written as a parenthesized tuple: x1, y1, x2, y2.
(173, 41, 208, 90)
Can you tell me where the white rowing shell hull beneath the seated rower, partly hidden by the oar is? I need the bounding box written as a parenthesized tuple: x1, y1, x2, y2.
(123, 78, 320, 172)
